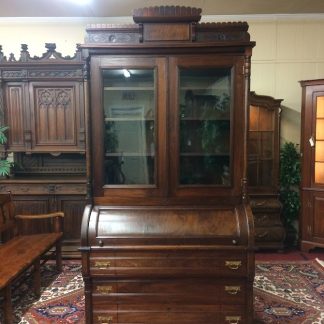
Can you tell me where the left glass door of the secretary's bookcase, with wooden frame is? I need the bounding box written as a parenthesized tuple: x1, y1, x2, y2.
(90, 55, 167, 197)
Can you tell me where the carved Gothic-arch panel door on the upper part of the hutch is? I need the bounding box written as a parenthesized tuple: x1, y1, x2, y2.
(29, 82, 83, 152)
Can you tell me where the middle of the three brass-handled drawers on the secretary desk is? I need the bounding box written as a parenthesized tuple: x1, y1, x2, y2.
(92, 278, 246, 309)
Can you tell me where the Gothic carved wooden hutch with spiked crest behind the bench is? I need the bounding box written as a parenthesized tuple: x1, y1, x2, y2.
(0, 43, 86, 256)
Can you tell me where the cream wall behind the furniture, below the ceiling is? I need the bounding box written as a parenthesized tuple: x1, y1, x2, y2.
(0, 14, 324, 143)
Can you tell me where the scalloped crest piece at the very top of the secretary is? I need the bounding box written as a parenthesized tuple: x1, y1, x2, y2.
(133, 6, 201, 23)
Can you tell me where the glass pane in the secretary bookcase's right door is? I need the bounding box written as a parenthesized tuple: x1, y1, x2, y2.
(179, 68, 231, 186)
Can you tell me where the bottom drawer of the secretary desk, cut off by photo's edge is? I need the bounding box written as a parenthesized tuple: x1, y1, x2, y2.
(93, 304, 246, 324)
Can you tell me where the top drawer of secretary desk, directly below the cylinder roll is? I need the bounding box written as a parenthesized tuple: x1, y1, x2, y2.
(90, 251, 247, 278)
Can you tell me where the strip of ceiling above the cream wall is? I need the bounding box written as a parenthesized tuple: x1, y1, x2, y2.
(0, 0, 324, 17)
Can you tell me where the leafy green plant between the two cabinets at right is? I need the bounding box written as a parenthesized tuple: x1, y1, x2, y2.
(279, 142, 301, 247)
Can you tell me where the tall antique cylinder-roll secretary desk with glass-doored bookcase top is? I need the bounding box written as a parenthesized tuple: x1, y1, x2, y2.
(81, 7, 254, 324)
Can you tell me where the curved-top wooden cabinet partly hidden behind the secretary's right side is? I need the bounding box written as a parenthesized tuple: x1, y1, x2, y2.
(247, 92, 286, 250)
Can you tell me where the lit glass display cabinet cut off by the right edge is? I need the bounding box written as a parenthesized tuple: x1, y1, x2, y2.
(299, 79, 324, 252)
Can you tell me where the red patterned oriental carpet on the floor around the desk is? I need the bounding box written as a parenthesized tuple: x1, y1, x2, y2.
(0, 261, 324, 324)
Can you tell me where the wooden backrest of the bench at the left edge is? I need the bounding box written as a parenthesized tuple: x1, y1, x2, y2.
(0, 193, 16, 241)
